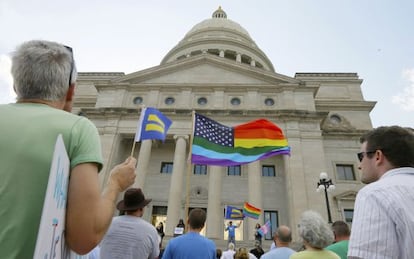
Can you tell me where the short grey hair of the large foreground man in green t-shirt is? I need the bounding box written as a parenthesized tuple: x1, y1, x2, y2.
(11, 40, 77, 101)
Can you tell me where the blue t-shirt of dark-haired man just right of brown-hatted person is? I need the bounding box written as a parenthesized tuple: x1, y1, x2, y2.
(162, 232, 216, 259)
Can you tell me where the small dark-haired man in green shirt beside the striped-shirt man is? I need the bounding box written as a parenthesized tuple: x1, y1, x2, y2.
(325, 220, 351, 259)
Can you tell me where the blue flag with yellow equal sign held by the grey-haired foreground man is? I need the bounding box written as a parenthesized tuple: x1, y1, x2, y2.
(135, 107, 172, 142)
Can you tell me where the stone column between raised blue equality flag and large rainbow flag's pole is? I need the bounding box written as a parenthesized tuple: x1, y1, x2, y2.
(165, 135, 188, 236)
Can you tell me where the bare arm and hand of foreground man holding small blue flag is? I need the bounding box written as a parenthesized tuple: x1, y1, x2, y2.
(66, 157, 136, 254)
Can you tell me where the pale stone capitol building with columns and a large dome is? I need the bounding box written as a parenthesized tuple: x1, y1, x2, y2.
(73, 7, 375, 248)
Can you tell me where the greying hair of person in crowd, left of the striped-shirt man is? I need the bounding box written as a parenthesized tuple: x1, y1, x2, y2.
(299, 210, 334, 248)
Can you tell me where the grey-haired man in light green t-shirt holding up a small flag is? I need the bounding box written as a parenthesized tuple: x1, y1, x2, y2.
(0, 41, 136, 259)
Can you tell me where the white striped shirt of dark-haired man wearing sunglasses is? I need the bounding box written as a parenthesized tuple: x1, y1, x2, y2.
(348, 167, 414, 259)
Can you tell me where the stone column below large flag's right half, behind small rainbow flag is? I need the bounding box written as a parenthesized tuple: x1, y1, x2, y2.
(244, 161, 264, 240)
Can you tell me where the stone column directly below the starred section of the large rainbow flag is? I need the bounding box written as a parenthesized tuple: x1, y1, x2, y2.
(206, 166, 225, 239)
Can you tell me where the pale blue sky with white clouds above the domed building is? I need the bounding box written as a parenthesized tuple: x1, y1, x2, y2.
(0, 0, 414, 127)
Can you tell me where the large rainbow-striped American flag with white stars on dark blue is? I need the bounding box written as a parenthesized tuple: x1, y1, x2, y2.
(191, 113, 290, 166)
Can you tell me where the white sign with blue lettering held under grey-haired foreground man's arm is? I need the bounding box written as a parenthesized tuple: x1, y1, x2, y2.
(33, 135, 87, 259)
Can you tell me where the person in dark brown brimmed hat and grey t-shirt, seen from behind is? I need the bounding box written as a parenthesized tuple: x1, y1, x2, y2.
(100, 188, 160, 259)
